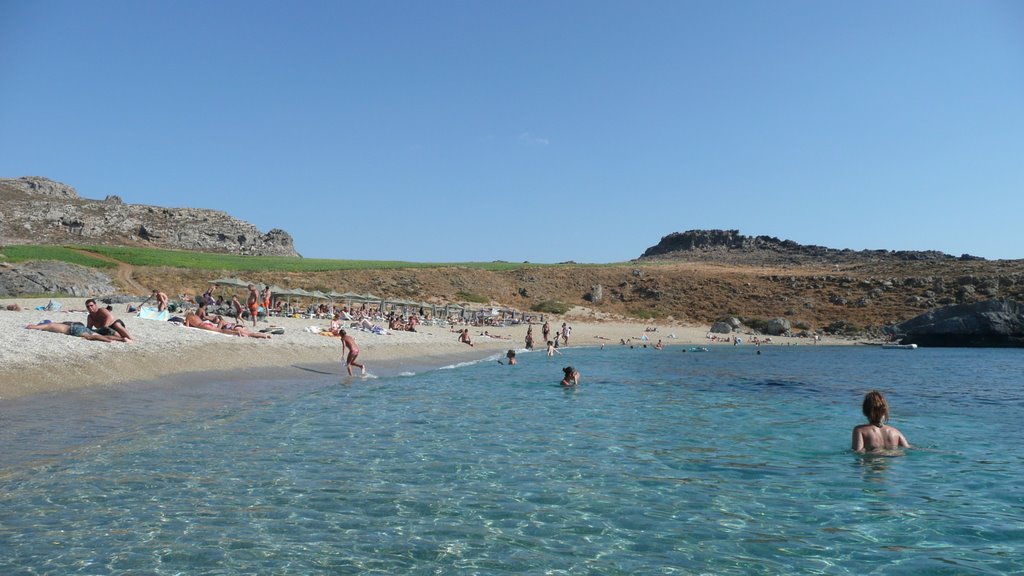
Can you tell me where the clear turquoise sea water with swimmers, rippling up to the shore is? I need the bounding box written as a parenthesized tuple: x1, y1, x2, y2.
(0, 346, 1024, 575)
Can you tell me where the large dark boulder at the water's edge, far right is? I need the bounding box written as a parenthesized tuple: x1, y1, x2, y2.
(889, 299, 1024, 347)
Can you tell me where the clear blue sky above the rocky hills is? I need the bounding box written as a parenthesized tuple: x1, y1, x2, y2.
(0, 0, 1024, 262)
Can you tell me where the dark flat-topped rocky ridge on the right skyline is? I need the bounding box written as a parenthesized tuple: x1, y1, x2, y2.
(640, 230, 983, 265)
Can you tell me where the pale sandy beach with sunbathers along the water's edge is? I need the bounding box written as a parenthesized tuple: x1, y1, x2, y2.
(0, 298, 849, 401)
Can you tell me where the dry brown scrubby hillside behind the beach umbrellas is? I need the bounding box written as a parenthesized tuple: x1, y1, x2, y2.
(125, 255, 1024, 332)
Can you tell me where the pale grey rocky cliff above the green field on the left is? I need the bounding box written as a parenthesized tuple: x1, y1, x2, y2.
(0, 176, 299, 256)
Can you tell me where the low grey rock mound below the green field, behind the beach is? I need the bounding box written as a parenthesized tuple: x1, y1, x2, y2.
(0, 260, 116, 298)
